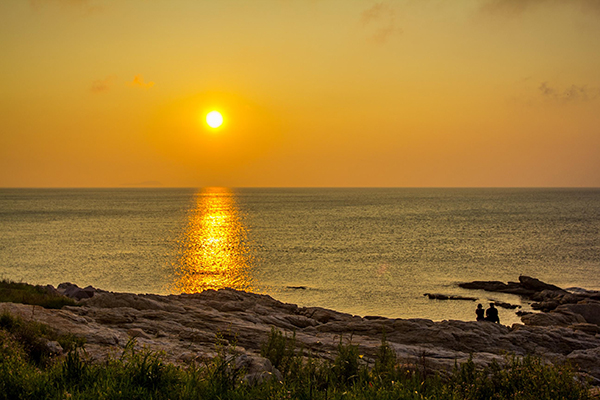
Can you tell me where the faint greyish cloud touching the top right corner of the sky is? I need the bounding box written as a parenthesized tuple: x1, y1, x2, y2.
(481, 0, 600, 15)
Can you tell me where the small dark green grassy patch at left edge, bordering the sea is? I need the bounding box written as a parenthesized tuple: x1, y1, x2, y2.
(0, 279, 78, 308)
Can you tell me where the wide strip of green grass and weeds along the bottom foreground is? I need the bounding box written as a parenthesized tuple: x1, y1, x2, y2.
(0, 313, 590, 400)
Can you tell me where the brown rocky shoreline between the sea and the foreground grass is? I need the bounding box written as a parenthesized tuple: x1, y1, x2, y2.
(0, 277, 600, 384)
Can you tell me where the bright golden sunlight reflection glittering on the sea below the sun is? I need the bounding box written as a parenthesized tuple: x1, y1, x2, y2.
(174, 188, 252, 293)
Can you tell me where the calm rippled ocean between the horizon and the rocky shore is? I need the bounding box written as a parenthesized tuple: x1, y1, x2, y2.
(0, 188, 600, 324)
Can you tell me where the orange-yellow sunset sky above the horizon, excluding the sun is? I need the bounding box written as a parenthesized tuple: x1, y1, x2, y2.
(0, 0, 600, 187)
